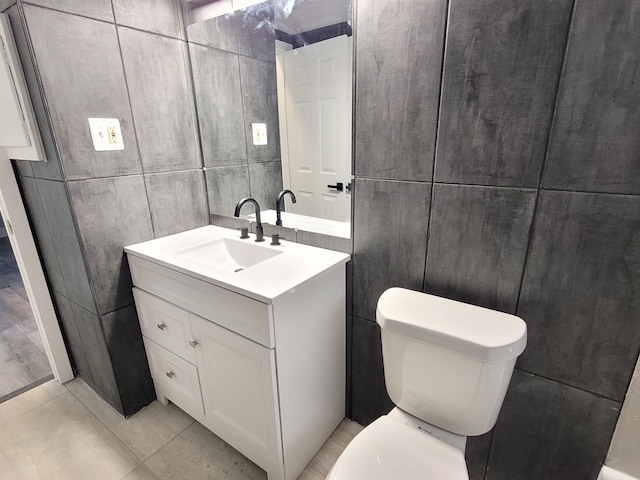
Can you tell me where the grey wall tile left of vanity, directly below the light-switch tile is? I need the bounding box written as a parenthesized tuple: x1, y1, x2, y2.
(68, 176, 153, 314)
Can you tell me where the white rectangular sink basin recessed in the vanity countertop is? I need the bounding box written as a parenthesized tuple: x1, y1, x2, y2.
(174, 238, 282, 273)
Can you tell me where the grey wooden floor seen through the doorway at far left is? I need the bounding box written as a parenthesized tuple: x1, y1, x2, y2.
(0, 238, 52, 403)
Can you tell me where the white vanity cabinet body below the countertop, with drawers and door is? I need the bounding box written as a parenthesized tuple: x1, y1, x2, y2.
(128, 234, 348, 480)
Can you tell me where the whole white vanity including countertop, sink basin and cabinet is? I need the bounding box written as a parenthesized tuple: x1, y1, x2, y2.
(125, 226, 349, 480)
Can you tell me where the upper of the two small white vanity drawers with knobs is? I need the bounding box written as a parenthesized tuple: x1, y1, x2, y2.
(133, 288, 196, 363)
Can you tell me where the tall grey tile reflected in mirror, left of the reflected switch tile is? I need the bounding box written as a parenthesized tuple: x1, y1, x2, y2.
(189, 44, 247, 167)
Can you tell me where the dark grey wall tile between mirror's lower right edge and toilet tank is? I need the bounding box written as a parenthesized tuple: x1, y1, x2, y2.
(353, 179, 431, 320)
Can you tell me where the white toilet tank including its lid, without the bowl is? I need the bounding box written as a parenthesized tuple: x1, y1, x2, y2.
(376, 288, 527, 436)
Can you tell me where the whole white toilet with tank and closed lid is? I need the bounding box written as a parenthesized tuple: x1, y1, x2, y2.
(327, 288, 527, 480)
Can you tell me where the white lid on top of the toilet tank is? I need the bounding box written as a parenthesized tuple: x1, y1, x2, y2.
(376, 287, 527, 363)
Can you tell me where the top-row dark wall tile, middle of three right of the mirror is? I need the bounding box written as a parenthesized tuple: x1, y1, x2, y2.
(435, 0, 572, 187)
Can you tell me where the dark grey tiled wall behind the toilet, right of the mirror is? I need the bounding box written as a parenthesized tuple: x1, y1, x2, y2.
(348, 0, 640, 480)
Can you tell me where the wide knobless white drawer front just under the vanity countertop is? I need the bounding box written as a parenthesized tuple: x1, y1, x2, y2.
(127, 255, 275, 348)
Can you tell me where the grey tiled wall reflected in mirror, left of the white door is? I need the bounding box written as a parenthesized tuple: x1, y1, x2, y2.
(188, 13, 282, 215)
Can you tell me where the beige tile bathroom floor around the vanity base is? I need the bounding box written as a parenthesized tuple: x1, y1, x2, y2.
(0, 378, 362, 480)
